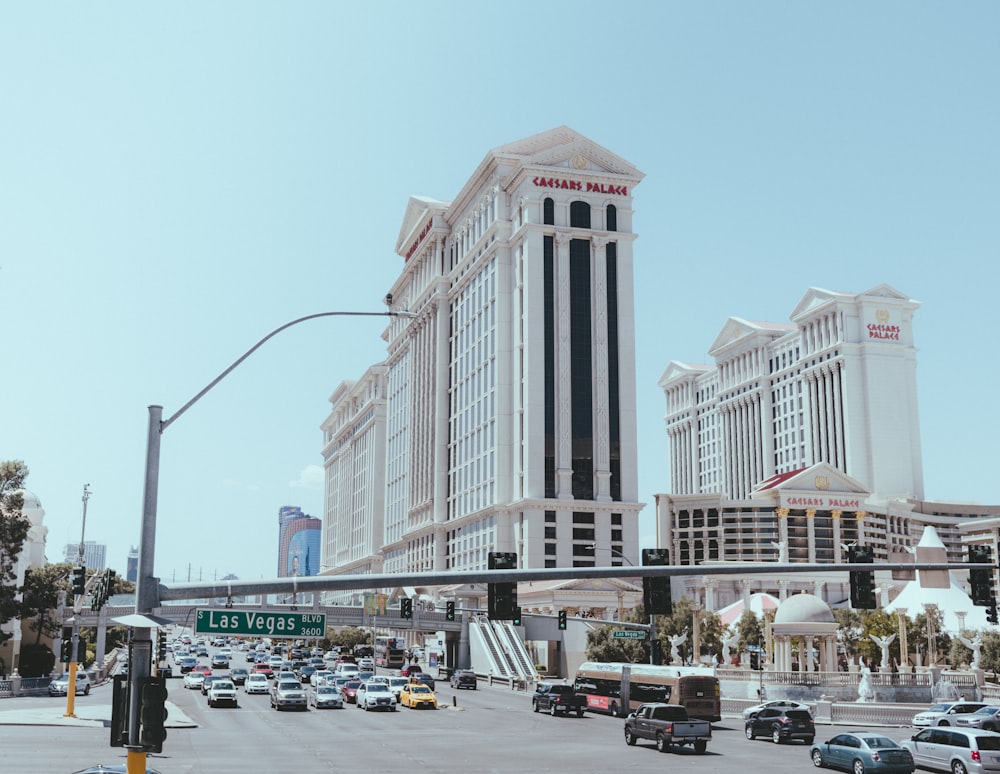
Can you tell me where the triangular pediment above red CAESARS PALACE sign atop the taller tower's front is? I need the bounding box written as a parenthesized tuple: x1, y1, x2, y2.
(490, 126, 644, 180)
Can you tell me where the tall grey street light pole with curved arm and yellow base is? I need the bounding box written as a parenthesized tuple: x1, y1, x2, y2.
(126, 309, 406, 774)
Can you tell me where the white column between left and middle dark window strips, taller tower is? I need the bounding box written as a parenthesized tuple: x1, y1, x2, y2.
(553, 232, 573, 500)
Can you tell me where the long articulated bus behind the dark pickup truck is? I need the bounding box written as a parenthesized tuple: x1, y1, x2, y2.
(573, 661, 722, 721)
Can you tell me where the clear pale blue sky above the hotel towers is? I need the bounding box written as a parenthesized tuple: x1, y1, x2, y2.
(0, 0, 1000, 583)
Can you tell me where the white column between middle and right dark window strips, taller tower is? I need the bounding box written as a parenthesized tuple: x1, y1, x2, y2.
(590, 237, 611, 503)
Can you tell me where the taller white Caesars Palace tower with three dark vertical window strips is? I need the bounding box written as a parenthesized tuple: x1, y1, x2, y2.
(323, 127, 643, 573)
